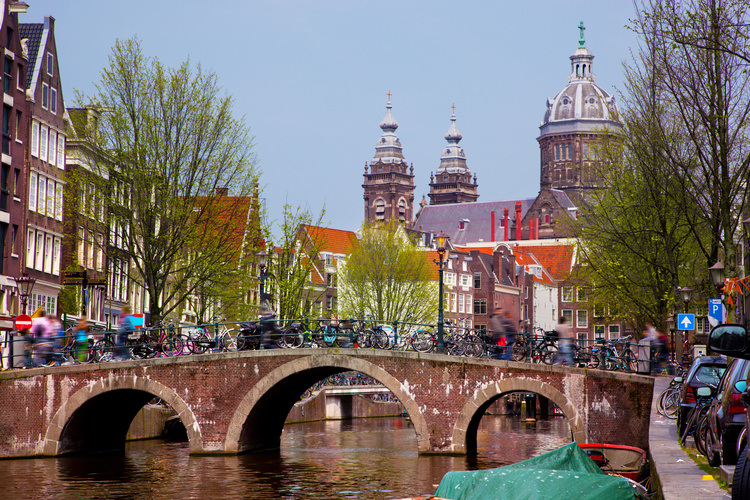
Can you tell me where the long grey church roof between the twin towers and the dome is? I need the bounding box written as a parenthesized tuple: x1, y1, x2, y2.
(413, 198, 535, 245)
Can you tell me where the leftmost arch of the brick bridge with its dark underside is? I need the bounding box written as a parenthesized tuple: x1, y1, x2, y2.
(43, 374, 203, 456)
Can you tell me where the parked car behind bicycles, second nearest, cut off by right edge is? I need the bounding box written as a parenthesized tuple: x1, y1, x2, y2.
(703, 359, 750, 467)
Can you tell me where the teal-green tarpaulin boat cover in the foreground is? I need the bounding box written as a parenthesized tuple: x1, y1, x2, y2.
(435, 443, 640, 500)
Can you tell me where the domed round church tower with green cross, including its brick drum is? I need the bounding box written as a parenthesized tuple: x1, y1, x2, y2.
(537, 21, 622, 204)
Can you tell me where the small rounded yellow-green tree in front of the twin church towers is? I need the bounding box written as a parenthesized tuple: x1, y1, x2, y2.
(339, 223, 438, 323)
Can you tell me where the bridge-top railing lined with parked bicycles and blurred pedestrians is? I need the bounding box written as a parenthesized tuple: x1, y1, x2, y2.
(3, 316, 674, 373)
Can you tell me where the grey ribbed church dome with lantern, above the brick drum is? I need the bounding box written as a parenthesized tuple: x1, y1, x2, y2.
(540, 38, 620, 135)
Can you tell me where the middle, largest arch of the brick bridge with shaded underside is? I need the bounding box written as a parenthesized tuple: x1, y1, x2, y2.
(224, 355, 431, 453)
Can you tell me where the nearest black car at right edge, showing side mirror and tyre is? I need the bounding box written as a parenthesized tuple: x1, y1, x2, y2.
(708, 325, 750, 498)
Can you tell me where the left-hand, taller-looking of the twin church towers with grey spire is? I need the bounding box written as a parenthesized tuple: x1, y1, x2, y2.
(362, 92, 414, 224)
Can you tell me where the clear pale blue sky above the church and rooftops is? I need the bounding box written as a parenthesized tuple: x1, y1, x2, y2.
(26, 0, 637, 234)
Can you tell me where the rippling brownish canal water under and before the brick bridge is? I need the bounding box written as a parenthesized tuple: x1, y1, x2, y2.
(0, 415, 571, 500)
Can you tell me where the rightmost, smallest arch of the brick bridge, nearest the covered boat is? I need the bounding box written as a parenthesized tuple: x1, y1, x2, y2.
(453, 378, 586, 453)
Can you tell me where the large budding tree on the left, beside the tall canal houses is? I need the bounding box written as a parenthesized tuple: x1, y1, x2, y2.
(84, 39, 258, 321)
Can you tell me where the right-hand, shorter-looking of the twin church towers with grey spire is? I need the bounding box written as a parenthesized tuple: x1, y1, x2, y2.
(429, 106, 479, 205)
